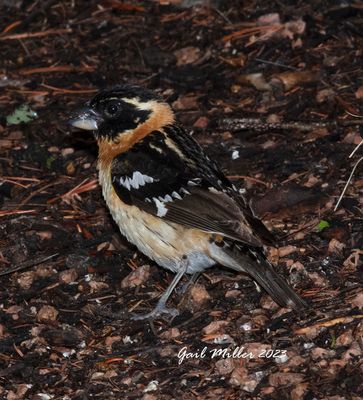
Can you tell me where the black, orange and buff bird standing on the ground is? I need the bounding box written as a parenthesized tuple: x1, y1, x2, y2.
(69, 84, 307, 319)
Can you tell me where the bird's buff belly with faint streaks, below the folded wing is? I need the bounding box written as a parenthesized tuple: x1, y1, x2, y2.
(100, 176, 216, 274)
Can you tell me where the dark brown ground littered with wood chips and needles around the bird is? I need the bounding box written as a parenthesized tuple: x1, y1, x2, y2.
(0, 0, 363, 400)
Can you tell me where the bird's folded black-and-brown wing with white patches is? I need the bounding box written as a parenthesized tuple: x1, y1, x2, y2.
(111, 127, 269, 247)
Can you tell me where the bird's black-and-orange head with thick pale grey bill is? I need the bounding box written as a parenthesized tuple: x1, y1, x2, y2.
(69, 85, 174, 144)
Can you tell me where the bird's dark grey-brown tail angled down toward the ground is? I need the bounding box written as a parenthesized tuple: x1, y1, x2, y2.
(212, 244, 307, 311)
